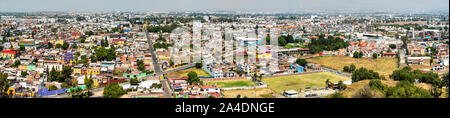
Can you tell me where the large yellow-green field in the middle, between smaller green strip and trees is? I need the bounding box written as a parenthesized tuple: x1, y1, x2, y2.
(263, 72, 351, 93)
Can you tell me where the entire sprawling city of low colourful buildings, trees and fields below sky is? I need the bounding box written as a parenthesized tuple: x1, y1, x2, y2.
(0, 0, 449, 99)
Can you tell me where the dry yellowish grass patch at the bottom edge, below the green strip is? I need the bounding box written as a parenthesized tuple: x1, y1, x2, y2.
(222, 88, 274, 98)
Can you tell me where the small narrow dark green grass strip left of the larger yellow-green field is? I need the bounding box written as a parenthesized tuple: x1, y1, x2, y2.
(205, 80, 256, 88)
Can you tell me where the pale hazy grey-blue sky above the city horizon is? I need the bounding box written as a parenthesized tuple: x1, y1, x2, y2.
(0, 0, 449, 12)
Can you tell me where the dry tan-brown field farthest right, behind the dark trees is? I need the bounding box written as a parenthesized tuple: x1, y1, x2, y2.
(306, 56, 399, 78)
